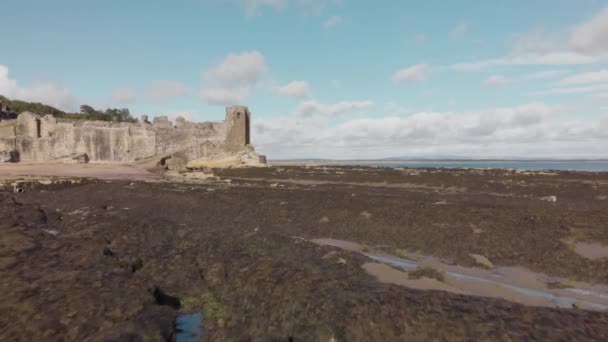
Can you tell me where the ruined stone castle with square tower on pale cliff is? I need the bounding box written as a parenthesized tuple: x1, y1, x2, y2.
(0, 106, 265, 166)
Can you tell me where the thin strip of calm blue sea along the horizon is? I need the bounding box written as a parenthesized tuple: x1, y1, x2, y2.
(348, 160, 608, 172)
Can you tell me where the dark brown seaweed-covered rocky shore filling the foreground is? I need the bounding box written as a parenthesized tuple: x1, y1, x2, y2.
(0, 166, 608, 341)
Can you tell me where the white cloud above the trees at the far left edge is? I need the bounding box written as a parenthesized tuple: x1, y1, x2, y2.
(0, 65, 78, 111)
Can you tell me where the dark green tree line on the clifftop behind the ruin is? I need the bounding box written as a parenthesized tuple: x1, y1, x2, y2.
(0, 95, 137, 122)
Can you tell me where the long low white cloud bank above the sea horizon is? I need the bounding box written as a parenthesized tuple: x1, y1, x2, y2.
(252, 103, 608, 159)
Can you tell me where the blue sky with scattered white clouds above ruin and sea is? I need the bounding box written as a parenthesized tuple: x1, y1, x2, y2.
(0, 0, 608, 159)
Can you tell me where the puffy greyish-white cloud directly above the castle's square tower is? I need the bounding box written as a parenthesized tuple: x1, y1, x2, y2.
(201, 51, 268, 105)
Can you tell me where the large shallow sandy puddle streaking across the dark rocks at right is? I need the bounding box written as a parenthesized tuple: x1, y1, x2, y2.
(311, 239, 608, 310)
